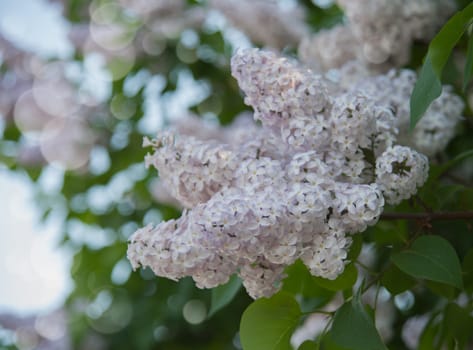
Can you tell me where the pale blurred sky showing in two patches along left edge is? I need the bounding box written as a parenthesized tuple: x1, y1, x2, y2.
(0, 0, 72, 315)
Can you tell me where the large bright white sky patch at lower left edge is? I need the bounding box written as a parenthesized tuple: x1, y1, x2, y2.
(0, 169, 72, 315)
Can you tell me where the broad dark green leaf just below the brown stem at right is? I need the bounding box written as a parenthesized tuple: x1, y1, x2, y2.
(391, 236, 463, 289)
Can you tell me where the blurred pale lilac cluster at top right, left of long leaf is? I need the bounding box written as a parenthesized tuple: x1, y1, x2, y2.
(299, 0, 455, 70)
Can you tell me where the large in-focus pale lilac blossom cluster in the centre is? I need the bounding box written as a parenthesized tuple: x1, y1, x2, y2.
(128, 49, 427, 298)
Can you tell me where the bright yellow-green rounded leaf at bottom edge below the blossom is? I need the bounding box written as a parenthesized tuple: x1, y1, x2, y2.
(240, 292, 301, 350)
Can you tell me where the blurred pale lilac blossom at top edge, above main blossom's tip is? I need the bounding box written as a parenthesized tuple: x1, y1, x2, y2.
(209, 0, 309, 49)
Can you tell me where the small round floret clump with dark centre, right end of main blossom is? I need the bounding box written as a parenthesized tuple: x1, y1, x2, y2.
(376, 146, 429, 204)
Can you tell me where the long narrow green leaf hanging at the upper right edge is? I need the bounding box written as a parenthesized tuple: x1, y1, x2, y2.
(410, 4, 473, 130)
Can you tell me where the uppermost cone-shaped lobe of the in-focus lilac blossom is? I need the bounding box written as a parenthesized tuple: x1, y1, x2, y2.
(231, 49, 329, 129)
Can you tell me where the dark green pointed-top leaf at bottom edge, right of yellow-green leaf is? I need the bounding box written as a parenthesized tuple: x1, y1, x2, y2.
(330, 295, 387, 350)
